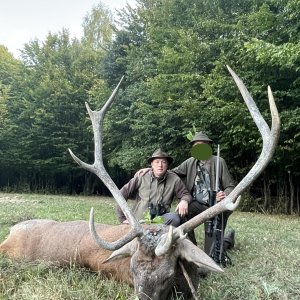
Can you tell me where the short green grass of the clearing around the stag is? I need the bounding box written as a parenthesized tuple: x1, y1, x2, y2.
(0, 193, 300, 300)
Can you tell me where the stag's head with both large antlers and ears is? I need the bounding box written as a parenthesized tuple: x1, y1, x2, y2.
(69, 67, 280, 300)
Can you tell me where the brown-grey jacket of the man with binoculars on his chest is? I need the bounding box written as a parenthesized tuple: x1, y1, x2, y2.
(117, 171, 192, 222)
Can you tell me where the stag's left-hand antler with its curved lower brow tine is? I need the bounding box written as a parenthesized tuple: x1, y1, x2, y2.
(69, 76, 143, 250)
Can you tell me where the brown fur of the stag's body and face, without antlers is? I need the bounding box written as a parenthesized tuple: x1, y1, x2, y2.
(0, 220, 206, 300)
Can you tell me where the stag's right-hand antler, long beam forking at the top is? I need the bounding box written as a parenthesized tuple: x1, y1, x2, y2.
(173, 66, 280, 239)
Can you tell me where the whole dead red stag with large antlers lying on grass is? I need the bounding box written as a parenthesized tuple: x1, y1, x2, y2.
(0, 67, 280, 300)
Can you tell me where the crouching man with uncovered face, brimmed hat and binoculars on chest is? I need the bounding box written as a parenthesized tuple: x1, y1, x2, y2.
(117, 149, 192, 227)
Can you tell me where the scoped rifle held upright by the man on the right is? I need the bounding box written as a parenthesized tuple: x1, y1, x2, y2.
(204, 145, 232, 267)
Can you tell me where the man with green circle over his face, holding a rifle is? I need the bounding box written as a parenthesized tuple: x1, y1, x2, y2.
(172, 132, 235, 250)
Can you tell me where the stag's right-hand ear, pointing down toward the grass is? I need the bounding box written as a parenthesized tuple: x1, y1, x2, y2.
(177, 239, 224, 272)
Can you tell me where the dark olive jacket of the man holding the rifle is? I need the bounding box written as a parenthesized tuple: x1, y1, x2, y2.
(172, 155, 235, 196)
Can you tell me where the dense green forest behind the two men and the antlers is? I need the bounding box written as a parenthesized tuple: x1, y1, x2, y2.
(0, 0, 300, 214)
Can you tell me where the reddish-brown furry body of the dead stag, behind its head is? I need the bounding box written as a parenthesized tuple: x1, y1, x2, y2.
(0, 220, 133, 285)
